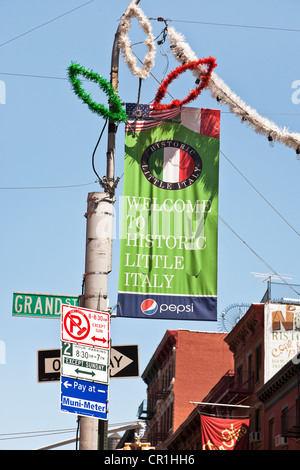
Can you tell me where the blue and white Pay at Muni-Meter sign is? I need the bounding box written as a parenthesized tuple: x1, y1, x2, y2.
(60, 377, 108, 420)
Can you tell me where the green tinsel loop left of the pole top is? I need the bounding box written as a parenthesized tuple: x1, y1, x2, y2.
(68, 62, 128, 122)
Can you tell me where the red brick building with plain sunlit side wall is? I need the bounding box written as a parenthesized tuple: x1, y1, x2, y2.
(138, 330, 233, 449)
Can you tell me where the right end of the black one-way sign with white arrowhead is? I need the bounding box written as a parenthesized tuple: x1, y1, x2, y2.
(110, 344, 139, 378)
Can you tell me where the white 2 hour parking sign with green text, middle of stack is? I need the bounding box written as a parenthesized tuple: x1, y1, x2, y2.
(61, 342, 109, 384)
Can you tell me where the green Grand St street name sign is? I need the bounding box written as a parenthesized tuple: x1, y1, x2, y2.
(12, 292, 79, 318)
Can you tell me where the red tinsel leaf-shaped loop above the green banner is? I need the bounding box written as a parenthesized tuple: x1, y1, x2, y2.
(153, 57, 217, 110)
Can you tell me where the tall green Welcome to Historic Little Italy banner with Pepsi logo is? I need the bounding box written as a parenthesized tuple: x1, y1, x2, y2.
(117, 105, 220, 321)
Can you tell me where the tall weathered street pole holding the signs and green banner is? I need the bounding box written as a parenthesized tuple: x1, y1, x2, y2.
(79, 0, 140, 450)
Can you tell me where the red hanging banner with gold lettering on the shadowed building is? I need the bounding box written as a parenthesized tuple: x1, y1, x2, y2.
(200, 415, 249, 450)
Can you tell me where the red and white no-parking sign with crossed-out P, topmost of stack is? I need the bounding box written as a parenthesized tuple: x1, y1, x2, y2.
(61, 305, 109, 349)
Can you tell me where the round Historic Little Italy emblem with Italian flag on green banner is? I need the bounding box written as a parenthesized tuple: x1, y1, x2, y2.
(141, 140, 202, 190)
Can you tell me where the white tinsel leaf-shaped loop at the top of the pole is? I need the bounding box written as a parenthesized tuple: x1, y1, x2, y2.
(118, 3, 156, 79)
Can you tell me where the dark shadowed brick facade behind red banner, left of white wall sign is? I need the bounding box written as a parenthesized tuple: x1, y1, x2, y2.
(167, 304, 264, 450)
